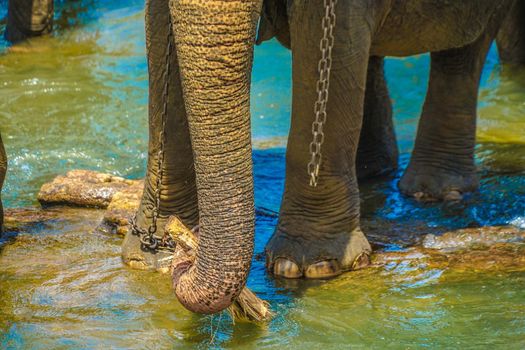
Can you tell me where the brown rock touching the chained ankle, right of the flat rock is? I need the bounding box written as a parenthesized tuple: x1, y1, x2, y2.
(99, 181, 144, 235)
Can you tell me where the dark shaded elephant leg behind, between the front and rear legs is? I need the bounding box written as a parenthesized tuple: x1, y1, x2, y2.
(357, 57, 398, 179)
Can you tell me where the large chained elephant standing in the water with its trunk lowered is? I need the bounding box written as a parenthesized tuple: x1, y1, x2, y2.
(123, 0, 514, 313)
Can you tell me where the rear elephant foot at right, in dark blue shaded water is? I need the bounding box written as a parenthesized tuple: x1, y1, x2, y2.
(399, 166, 478, 202)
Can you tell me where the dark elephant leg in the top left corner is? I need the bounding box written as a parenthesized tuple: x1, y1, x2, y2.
(6, 0, 54, 43)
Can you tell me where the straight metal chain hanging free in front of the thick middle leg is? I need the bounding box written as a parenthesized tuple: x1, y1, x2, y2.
(308, 0, 337, 187)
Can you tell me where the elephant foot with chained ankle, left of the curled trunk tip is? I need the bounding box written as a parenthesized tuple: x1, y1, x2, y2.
(122, 221, 173, 273)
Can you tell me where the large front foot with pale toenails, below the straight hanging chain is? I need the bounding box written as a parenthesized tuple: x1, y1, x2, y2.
(266, 228, 372, 279)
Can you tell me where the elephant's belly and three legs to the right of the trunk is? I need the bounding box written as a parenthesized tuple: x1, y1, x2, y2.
(259, 0, 517, 278)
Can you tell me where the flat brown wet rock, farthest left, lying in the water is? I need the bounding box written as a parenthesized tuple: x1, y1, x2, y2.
(38, 170, 140, 208)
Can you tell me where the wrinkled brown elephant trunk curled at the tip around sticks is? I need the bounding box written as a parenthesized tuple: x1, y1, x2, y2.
(170, 0, 261, 313)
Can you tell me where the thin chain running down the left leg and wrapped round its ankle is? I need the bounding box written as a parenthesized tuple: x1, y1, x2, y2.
(130, 15, 175, 252)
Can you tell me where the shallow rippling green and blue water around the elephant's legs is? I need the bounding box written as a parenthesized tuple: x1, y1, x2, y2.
(0, 0, 525, 349)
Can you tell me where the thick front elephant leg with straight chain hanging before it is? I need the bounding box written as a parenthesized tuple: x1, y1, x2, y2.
(266, 1, 371, 278)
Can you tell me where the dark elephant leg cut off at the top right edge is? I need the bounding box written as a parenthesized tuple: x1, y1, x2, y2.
(496, 1, 525, 65)
